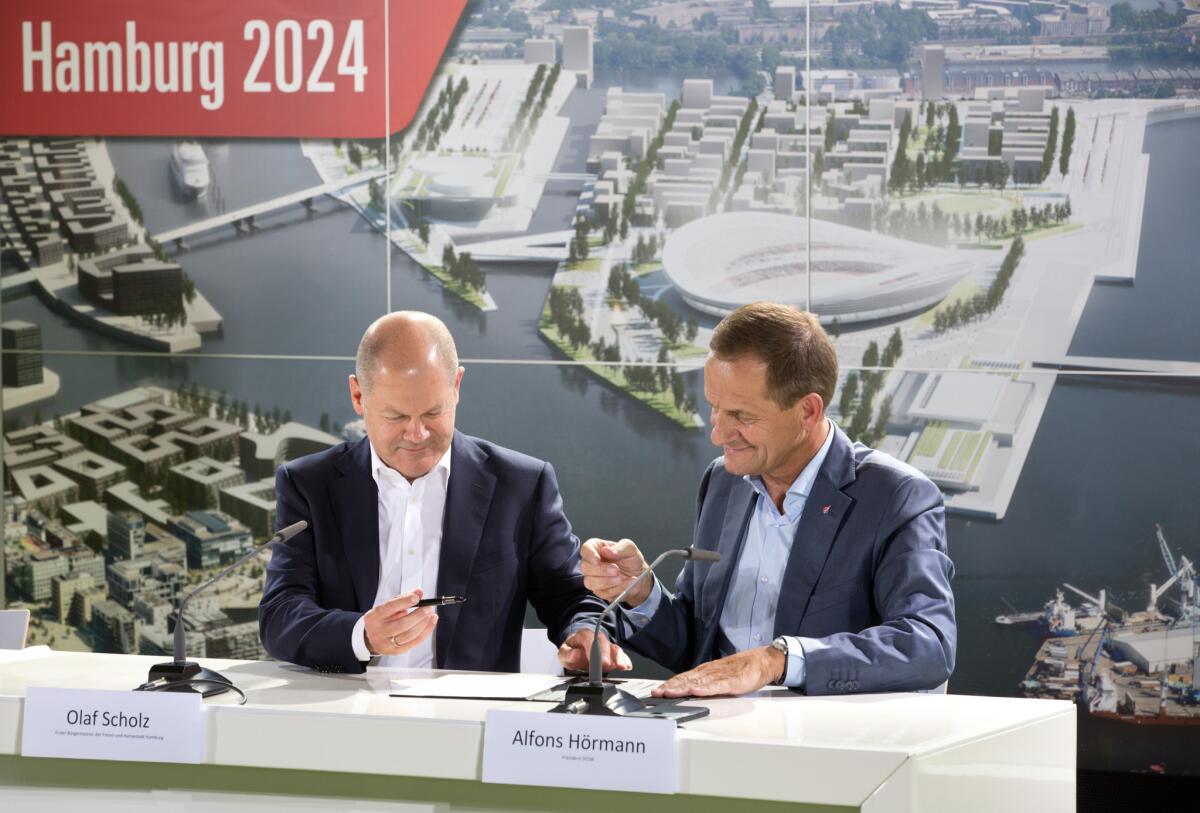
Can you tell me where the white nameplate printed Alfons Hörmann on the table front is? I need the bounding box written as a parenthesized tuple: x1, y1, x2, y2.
(484, 711, 679, 794)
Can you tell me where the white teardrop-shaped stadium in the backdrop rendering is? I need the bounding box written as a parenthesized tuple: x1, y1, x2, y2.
(662, 212, 978, 325)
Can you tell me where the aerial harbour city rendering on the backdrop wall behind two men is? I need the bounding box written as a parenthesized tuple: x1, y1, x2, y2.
(7, 0, 1200, 773)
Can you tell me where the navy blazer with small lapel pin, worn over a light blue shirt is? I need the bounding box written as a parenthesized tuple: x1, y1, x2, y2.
(623, 427, 956, 694)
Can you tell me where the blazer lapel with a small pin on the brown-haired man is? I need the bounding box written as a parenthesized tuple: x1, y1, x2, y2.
(775, 424, 854, 636)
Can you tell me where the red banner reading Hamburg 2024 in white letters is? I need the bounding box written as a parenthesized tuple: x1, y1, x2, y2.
(0, 0, 467, 138)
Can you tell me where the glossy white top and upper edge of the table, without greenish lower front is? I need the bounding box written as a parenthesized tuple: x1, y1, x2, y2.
(0, 648, 1075, 813)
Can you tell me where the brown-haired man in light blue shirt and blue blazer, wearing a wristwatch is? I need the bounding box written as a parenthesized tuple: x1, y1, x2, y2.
(581, 302, 956, 697)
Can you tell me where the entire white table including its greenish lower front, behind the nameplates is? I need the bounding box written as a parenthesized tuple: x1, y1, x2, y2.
(0, 646, 1076, 813)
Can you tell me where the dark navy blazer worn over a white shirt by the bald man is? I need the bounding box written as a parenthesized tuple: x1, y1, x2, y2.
(258, 432, 604, 673)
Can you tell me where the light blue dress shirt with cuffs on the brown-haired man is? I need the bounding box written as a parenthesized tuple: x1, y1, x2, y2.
(623, 418, 833, 688)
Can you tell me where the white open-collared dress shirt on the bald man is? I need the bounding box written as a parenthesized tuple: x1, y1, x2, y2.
(350, 442, 450, 669)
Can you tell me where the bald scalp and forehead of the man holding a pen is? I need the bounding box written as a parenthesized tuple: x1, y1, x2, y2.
(354, 311, 458, 392)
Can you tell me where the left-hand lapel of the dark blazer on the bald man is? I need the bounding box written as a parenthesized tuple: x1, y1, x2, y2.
(330, 438, 379, 612)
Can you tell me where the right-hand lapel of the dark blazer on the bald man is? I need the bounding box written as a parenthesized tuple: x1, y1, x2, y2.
(436, 430, 496, 667)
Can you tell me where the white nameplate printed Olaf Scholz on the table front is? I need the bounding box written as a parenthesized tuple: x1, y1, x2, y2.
(20, 688, 205, 763)
